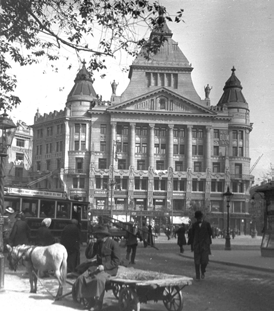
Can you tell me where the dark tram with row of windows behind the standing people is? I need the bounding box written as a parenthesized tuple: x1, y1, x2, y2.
(4, 188, 89, 243)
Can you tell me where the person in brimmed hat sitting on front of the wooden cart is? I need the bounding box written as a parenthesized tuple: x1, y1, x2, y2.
(72, 225, 120, 311)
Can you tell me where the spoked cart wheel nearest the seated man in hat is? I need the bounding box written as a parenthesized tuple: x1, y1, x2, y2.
(119, 287, 140, 311)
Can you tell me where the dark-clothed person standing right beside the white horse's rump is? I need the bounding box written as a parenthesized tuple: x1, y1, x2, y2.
(61, 219, 81, 273)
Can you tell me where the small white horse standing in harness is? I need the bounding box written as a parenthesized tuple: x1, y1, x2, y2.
(7, 243, 68, 300)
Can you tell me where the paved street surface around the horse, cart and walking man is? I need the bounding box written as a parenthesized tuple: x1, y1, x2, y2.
(0, 240, 274, 311)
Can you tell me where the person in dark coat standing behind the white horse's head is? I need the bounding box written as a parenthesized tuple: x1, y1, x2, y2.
(9, 212, 30, 246)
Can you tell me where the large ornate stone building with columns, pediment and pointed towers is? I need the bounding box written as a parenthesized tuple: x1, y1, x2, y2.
(30, 26, 252, 231)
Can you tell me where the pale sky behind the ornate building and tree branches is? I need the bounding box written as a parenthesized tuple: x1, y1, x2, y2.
(10, 0, 274, 183)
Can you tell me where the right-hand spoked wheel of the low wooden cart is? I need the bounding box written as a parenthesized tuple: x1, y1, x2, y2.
(163, 286, 184, 311)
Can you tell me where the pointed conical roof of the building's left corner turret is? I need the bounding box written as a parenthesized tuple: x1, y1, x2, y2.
(67, 62, 96, 102)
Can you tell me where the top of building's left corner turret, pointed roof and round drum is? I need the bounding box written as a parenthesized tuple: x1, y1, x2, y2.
(66, 61, 97, 117)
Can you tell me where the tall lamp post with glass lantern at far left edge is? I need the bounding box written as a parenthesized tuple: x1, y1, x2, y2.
(0, 111, 16, 291)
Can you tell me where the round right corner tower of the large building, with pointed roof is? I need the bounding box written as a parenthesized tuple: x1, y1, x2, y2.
(217, 67, 252, 193)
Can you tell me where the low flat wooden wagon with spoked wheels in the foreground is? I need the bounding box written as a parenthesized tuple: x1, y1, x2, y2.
(68, 269, 193, 311)
